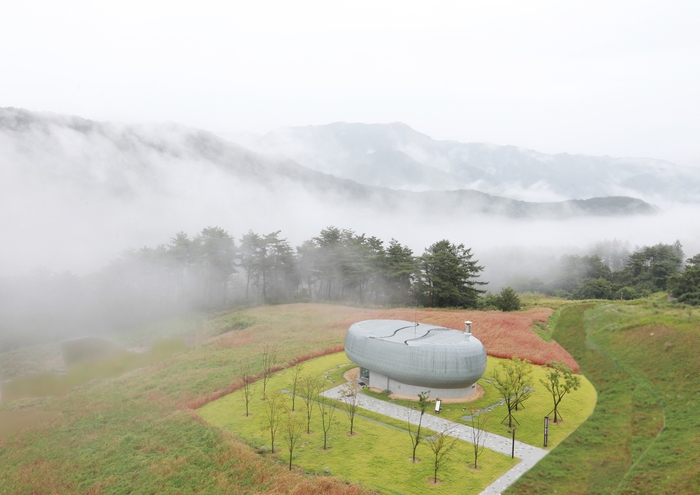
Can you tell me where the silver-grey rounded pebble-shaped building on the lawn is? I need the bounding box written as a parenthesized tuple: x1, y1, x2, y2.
(345, 320, 486, 399)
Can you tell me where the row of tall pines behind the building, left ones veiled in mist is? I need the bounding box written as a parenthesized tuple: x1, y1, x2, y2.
(109, 227, 484, 308)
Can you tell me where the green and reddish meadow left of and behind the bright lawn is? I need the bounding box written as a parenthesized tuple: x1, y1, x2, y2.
(0, 304, 570, 493)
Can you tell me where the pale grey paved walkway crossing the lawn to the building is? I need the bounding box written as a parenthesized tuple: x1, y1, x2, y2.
(323, 385, 549, 495)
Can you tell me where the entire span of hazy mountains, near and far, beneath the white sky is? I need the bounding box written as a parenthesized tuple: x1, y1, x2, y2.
(0, 108, 660, 225)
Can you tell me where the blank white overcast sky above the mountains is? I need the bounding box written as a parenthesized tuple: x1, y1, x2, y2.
(0, 0, 700, 165)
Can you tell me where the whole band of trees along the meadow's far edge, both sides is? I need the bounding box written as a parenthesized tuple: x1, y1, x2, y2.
(0, 227, 700, 356)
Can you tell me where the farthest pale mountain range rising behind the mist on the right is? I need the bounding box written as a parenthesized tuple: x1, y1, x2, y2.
(241, 122, 700, 202)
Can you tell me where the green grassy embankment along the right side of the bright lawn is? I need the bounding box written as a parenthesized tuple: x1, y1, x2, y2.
(509, 300, 700, 494)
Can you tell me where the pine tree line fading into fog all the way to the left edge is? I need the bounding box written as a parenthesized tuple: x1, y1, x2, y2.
(0, 227, 484, 349)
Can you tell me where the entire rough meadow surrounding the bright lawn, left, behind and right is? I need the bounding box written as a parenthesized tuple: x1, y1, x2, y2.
(0, 301, 700, 494)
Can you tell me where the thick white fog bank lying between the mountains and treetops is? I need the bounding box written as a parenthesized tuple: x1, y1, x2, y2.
(0, 110, 700, 283)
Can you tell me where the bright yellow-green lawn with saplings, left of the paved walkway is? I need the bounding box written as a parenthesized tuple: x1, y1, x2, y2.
(198, 352, 517, 494)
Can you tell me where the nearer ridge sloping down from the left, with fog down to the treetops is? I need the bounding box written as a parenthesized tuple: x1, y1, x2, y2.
(0, 108, 695, 277)
